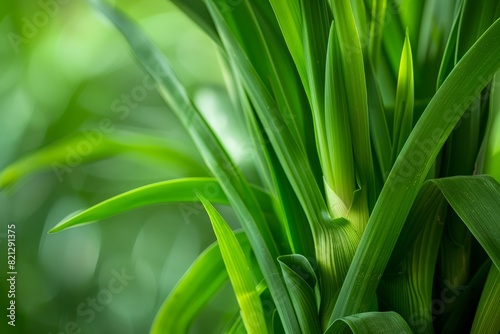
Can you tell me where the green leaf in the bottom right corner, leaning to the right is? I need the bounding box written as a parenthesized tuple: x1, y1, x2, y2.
(471, 266, 500, 334)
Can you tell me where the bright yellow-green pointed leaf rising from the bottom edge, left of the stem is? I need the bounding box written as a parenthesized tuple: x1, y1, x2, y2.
(198, 194, 267, 334)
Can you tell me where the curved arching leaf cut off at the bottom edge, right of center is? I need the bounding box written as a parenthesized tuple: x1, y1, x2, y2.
(325, 312, 412, 334)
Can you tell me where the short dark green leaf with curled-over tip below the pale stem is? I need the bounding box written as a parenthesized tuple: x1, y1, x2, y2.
(278, 254, 322, 334)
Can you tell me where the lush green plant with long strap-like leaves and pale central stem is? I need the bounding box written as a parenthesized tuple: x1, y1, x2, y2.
(0, 0, 500, 333)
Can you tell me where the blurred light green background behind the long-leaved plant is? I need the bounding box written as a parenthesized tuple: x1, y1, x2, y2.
(0, 0, 500, 334)
